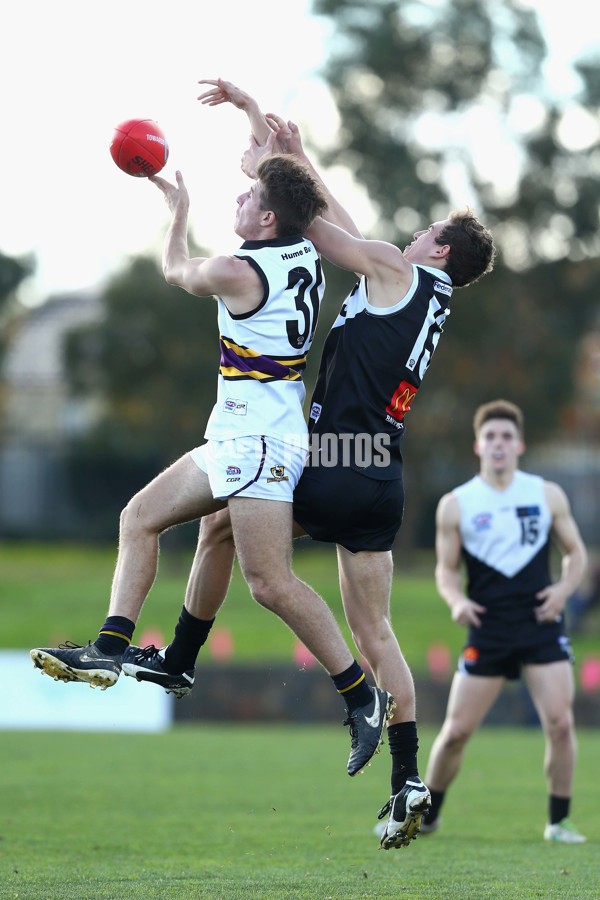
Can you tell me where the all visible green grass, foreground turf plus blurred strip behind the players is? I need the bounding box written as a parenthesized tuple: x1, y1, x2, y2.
(0, 544, 600, 900)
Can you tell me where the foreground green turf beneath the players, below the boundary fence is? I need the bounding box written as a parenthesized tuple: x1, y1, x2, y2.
(0, 725, 600, 900)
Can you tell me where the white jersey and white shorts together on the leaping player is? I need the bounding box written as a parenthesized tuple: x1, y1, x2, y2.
(190, 235, 325, 502)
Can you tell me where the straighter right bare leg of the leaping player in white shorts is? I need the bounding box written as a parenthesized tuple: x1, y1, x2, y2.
(229, 497, 354, 675)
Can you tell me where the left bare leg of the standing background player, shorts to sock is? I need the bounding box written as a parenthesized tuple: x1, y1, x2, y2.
(425, 672, 504, 791)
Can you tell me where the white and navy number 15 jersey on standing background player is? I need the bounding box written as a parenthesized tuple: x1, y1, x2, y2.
(453, 470, 552, 605)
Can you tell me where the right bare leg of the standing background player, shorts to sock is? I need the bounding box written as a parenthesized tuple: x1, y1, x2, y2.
(524, 660, 577, 797)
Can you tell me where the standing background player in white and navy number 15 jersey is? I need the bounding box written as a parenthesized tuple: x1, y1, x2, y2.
(421, 400, 586, 843)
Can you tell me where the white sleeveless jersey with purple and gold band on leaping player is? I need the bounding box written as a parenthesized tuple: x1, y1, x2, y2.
(205, 235, 325, 447)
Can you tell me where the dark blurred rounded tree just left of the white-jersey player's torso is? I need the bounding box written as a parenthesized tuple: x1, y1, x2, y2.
(65, 256, 219, 465)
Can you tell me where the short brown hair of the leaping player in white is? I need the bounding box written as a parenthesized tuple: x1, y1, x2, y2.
(256, 154, 327, 237)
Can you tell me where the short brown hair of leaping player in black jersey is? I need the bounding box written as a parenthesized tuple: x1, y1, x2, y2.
(435, 209, 496, 287)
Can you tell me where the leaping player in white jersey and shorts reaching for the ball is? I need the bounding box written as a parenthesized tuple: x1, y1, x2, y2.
(31, 141, 393, 775)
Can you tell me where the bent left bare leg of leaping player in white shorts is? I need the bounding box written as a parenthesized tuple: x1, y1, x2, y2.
(108, 455, 223, 622)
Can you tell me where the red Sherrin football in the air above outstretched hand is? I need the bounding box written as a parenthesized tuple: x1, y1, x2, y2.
(110, 119, 169, 178)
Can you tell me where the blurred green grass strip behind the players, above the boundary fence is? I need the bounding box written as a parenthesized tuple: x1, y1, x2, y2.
(0, 541, 600, 674)
